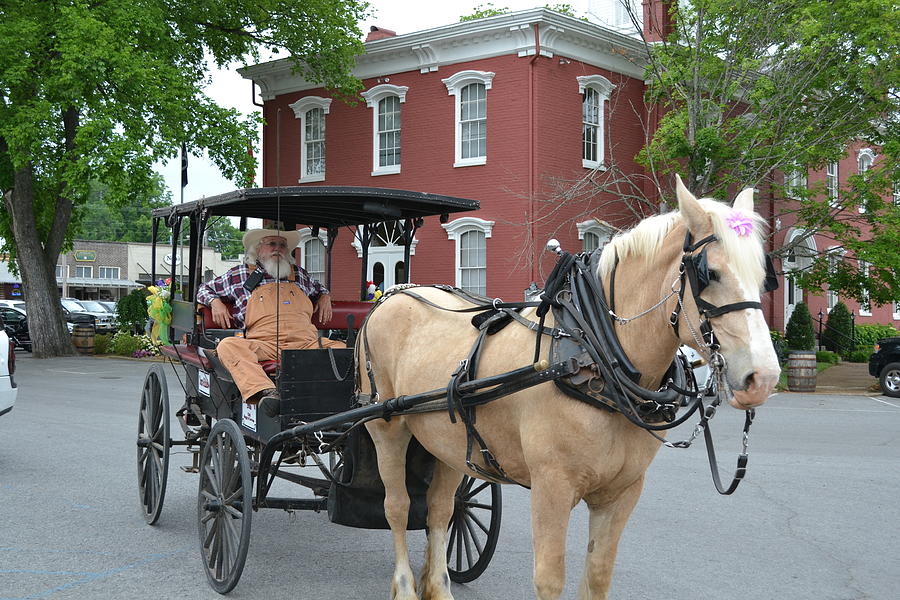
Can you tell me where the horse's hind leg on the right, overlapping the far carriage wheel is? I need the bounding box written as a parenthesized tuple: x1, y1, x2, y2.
(421, 461, 462, 600)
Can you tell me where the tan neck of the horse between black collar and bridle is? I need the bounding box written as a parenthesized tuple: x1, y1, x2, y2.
(604, 236, 680, 385)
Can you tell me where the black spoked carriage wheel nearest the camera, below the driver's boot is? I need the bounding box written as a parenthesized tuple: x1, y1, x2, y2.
(197, 419, 253, 594)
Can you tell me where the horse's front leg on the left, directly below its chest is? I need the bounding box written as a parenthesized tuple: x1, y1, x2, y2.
(531, 475, 576, 600)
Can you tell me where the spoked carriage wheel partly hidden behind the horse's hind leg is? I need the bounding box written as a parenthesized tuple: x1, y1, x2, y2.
(447, 475, 503, 583)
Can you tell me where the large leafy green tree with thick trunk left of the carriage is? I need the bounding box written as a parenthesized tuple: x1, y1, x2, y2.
(0, 0, 367, 357)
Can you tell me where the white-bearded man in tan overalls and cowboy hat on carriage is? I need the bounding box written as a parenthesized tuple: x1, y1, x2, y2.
(197, 229, 345, 404)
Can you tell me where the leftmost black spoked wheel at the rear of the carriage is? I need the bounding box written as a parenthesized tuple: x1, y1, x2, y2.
(137, 364, 171, 525)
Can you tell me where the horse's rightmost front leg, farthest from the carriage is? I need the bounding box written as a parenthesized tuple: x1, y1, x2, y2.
(578, 476, 644, 600)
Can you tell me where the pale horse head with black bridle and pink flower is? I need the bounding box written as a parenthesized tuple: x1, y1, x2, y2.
(676, 173, 781, 409)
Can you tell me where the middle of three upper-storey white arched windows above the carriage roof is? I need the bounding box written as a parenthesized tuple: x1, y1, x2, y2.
(362, 83, 409, 175)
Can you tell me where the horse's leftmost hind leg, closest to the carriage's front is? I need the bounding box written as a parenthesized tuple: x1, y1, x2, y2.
(366, 418, 419, 600)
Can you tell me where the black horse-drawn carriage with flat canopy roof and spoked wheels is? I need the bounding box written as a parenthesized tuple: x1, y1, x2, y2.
(137, 187, 501, 593)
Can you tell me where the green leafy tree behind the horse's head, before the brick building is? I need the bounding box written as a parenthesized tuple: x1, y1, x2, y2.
(545, 0, 900, 304)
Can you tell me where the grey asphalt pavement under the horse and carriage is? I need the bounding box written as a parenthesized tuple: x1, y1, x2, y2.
(0, 352, 900, 600)
